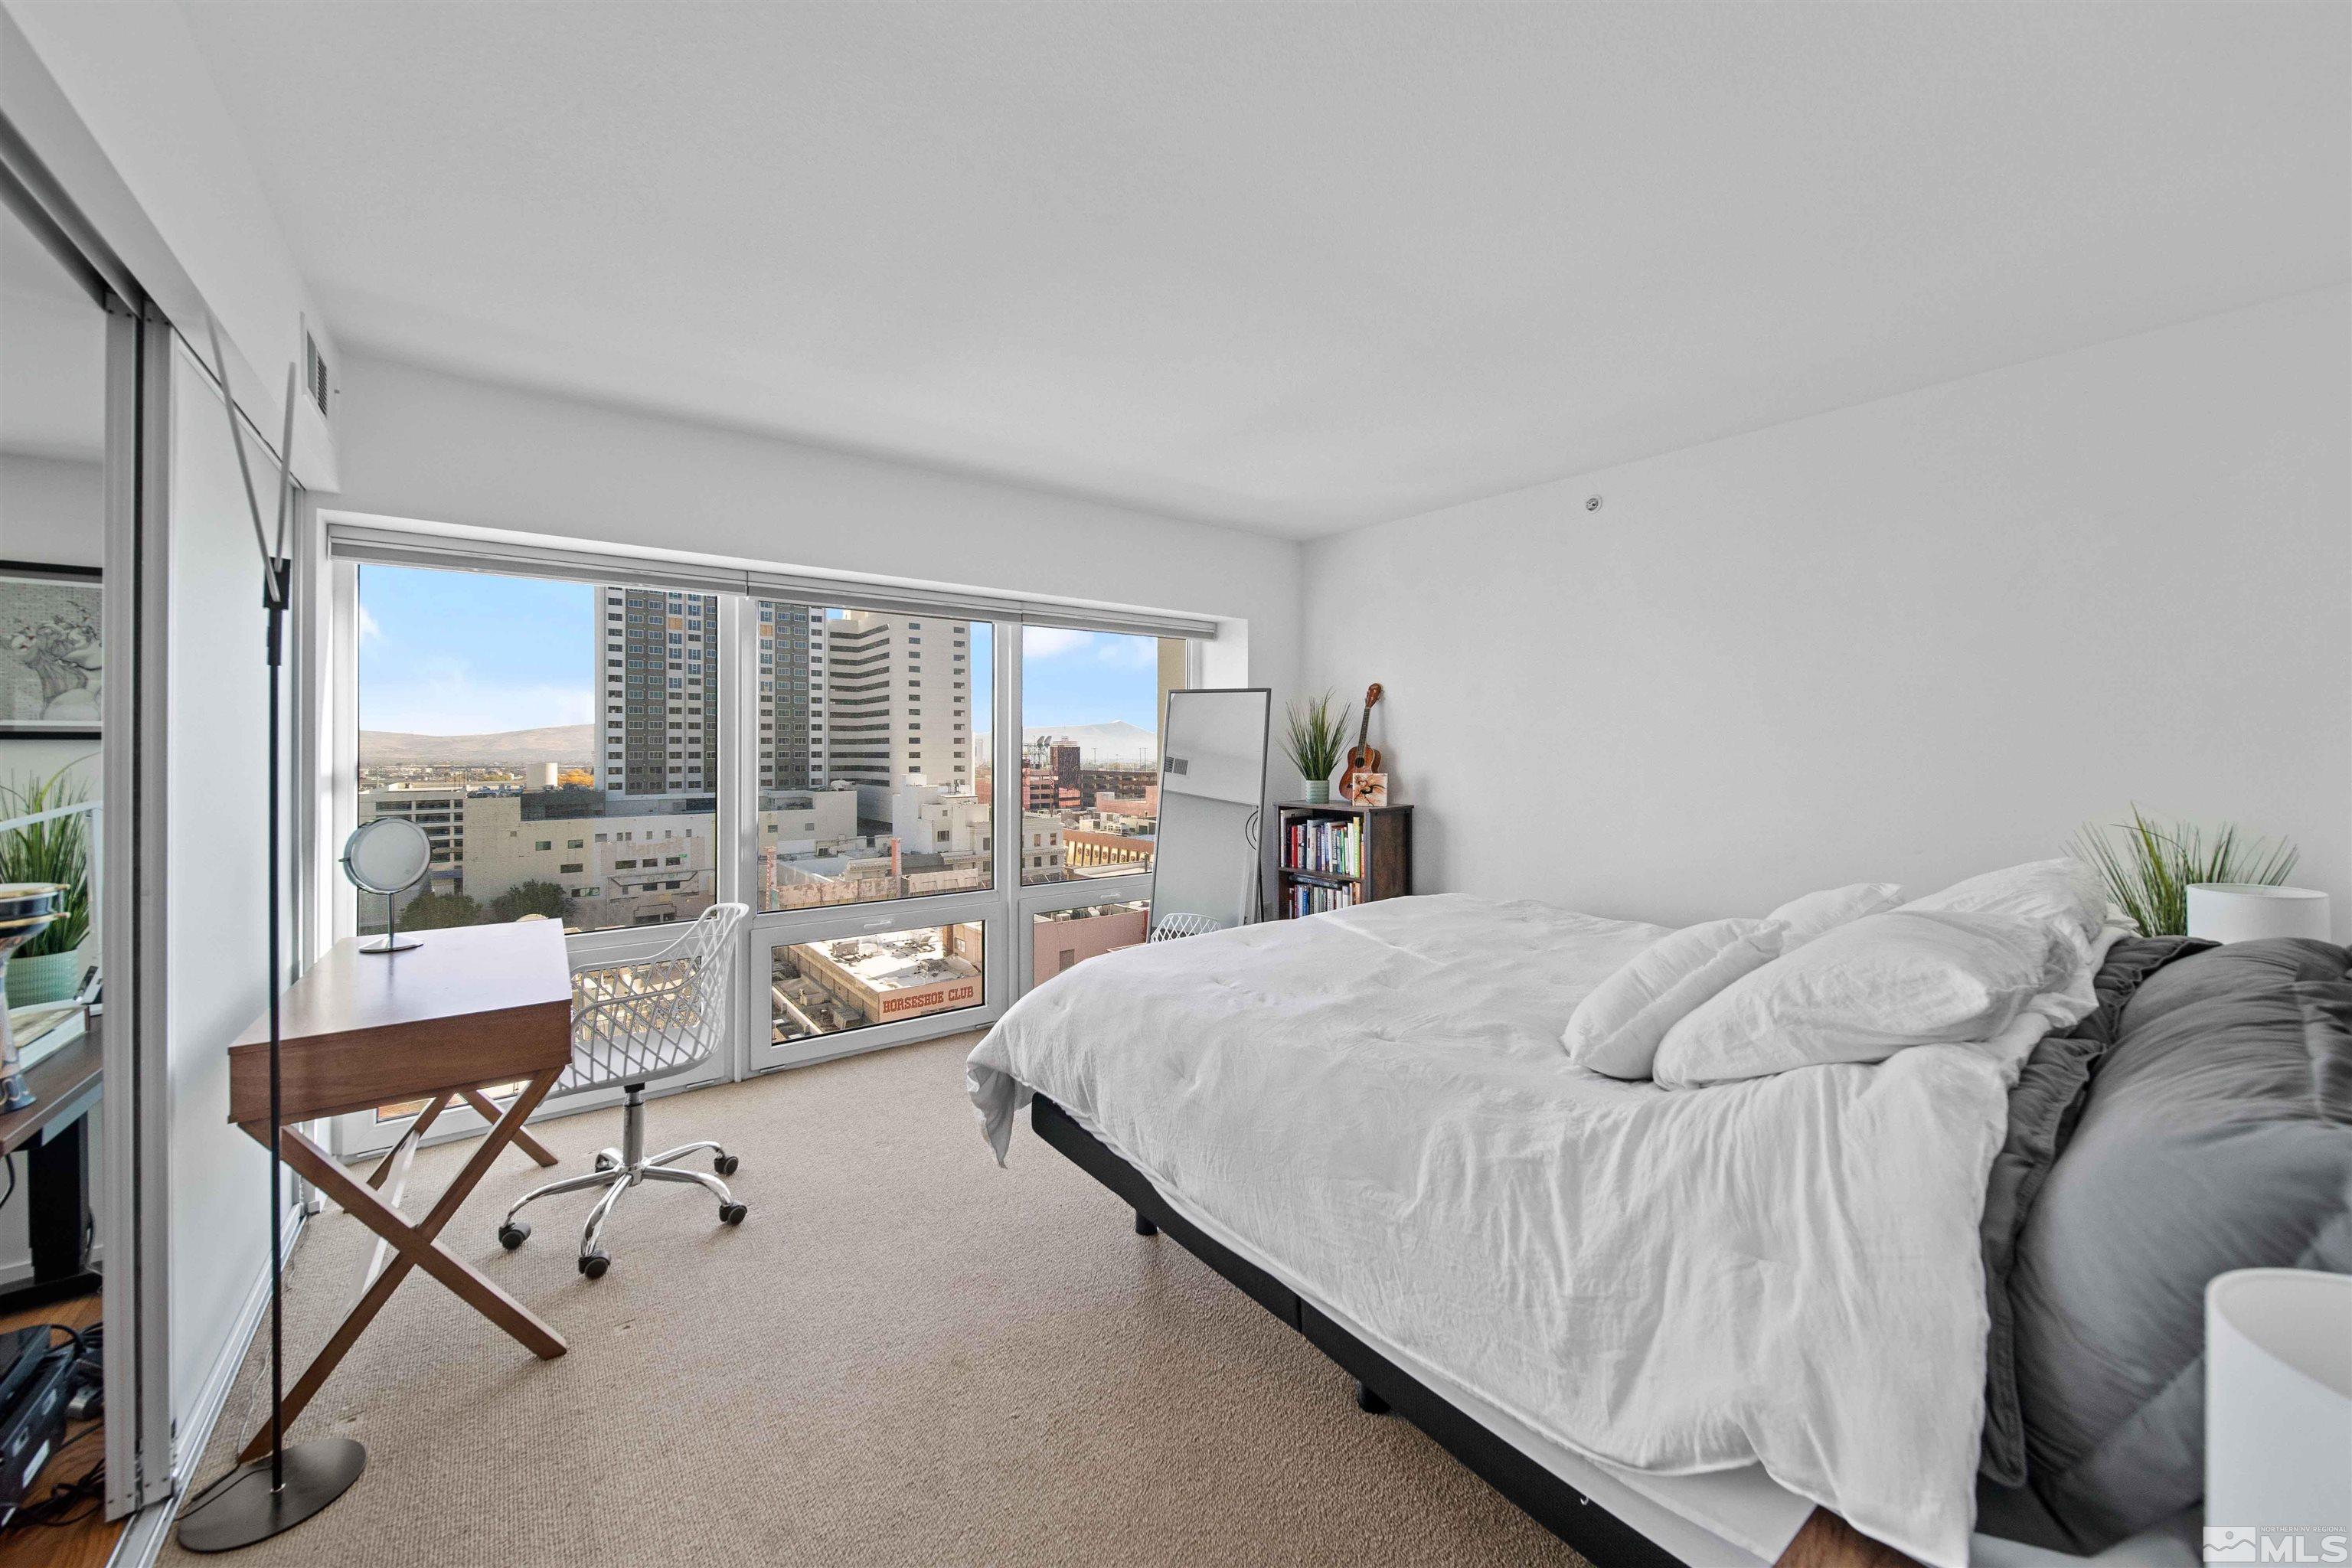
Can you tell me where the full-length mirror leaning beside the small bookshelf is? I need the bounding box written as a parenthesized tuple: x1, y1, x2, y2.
(1150, 687, 1272, 940)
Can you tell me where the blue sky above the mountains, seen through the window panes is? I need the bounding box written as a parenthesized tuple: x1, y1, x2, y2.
(360, 567, 1159, 736)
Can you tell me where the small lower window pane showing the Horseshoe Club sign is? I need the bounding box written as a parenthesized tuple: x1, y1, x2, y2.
(766, 922, 988, 1046)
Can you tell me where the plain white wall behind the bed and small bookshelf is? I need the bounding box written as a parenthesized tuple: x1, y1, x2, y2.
(1305, 287, 2352, 940)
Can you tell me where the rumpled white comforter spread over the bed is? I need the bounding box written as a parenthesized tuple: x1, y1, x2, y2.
(969, 896, 2105, 1568)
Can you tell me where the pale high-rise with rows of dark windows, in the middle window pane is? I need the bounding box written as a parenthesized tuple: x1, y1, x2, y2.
(823, 611, 972, 790)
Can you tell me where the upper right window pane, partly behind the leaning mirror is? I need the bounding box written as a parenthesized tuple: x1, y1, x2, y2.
(1021, 626, 1187, 887)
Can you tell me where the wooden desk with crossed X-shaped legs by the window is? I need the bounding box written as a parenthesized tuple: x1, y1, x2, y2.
(228, 920, 571, 1460)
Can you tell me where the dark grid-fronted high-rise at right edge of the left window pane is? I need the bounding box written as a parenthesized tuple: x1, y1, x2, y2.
(597, 583, 720, 795)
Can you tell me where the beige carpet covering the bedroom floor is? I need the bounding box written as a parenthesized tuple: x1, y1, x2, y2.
(167, 1037, 1580, 1568)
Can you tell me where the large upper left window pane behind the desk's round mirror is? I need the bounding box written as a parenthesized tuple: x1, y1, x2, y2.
(358, 564, 724, 931)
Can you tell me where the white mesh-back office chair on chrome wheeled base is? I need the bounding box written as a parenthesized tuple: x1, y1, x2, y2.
(498, 903, 750, 1279)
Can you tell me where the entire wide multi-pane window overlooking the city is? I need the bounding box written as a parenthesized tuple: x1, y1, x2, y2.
(341, 541, 1207, 1114)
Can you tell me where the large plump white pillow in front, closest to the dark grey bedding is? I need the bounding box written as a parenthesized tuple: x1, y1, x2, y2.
(1651, 910, 2065, 1089)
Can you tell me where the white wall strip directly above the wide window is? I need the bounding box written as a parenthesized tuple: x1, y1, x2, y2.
(325, 358, 1298, 684)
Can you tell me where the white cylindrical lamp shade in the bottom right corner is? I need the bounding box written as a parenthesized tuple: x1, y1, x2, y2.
(2207, 1269, 2352, 1530)
